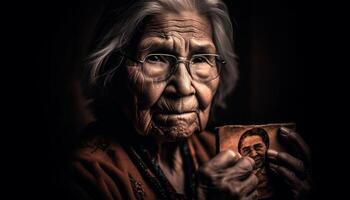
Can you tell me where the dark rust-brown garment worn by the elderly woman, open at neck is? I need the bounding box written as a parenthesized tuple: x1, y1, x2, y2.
(71, 122, 215, 199)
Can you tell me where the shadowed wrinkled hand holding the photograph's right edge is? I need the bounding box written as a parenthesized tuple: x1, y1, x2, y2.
(267, 127, 311, 200)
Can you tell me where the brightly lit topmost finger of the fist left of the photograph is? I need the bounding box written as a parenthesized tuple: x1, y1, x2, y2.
(209, 150, 242, 169)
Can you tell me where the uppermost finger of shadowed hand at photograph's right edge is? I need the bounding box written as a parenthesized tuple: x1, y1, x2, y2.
(279, 127, 311, 163)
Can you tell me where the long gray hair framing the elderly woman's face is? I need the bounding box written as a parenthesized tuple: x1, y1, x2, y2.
(83, 0, 238, 116)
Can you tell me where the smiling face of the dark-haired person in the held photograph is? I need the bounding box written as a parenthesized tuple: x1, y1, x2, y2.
(240, 135, 267, 169)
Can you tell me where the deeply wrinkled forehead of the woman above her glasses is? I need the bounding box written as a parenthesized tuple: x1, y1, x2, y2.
(139, 15, 215, 56)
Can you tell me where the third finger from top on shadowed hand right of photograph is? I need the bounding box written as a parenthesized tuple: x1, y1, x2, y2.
(270, 163, 302, 189)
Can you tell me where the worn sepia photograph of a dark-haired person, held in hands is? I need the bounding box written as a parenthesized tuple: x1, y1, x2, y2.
(216, 123, 308, 199)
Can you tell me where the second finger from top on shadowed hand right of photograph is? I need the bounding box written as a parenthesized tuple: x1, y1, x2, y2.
(267, 149, 306, 178)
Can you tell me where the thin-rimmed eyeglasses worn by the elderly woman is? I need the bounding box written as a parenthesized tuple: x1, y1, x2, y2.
(122, 54, 226, 82)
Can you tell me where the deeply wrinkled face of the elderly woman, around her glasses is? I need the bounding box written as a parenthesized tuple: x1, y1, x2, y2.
(125, 12, 219, 141)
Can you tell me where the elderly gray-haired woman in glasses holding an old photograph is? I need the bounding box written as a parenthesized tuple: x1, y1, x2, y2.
(72, 0, 308, 200)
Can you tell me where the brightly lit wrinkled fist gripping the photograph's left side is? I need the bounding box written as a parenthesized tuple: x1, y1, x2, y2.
(195, 150, 258, 200)
